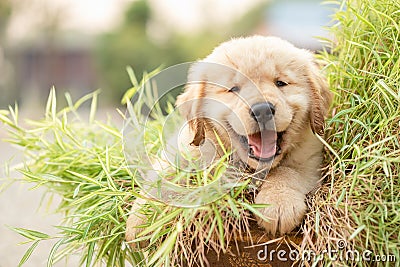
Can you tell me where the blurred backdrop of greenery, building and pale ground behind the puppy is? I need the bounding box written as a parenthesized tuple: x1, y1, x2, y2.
(0, 0, 332, 267)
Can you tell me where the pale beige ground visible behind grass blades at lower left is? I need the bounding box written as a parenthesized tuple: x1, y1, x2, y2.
(0, 110, 120, 267)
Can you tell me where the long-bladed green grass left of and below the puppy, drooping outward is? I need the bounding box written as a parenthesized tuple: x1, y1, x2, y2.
(0, 72, 262, 266)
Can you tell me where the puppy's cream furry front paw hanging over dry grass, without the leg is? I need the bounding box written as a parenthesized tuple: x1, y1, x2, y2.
(255, 188, 307, 235)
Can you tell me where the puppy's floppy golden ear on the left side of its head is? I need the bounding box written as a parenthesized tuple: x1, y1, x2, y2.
(175, 82, 206, 146)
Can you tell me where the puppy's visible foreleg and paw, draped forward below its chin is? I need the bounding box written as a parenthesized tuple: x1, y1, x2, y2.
(255, 167, 318, 234)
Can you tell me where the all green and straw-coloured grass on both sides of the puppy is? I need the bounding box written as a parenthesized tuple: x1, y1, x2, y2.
(0, 0, 400, 266)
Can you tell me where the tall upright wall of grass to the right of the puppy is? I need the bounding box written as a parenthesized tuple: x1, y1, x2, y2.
(301, 0, 400, 266)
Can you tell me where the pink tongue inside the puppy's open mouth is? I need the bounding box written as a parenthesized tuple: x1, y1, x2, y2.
(248, 130, 278, 158)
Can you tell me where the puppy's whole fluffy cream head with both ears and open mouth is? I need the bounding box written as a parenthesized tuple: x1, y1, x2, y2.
(177, 36, 330, 170)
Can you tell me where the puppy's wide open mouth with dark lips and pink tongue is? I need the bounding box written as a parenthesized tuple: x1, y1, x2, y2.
(240, 130, 284, 161)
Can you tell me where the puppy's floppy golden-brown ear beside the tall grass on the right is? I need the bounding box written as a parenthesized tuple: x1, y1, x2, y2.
(308, 62, 332, 136)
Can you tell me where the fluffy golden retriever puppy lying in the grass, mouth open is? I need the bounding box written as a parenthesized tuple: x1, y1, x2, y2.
(127, 36, 331, 240)
